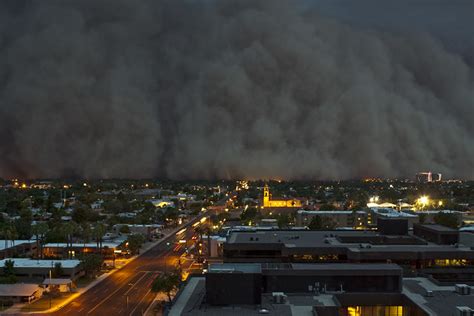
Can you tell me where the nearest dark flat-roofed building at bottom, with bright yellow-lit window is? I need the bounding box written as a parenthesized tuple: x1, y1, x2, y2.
(169, 264, 436, 316)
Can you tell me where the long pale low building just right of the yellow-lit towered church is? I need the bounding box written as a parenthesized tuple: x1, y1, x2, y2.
(296, 210, 368, 228)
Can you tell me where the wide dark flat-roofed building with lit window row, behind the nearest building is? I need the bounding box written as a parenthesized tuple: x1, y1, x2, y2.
(223, 230, 474, 282)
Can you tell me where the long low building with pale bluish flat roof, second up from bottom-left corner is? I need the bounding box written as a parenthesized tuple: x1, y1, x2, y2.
(0, 258, 83, 280)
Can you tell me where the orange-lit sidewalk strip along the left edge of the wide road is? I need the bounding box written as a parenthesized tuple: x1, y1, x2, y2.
(0, 215, 201, 315)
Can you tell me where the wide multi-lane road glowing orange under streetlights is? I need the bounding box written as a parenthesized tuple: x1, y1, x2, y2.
(54, 222, 200, 316)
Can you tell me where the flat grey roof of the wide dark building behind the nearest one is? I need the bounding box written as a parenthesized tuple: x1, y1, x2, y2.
(224, 230, 474, 258)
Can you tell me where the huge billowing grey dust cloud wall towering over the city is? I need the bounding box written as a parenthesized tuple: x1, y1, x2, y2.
(0, 0, 474, 179)
